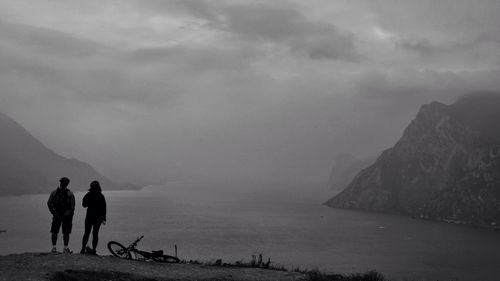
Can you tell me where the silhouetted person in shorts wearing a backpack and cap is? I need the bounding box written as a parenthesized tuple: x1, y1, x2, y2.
(47, 177, 75, 253)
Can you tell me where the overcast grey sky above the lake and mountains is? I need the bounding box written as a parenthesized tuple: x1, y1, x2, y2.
(0, 0, 500, 182)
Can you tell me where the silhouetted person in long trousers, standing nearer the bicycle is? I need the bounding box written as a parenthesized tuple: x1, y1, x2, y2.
(80, 181, 106, 255)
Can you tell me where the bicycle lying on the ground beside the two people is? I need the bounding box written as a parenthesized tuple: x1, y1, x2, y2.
(108, 235, 180, 263)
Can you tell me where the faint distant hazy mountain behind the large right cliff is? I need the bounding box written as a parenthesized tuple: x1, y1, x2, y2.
(328, 153, 374, 190)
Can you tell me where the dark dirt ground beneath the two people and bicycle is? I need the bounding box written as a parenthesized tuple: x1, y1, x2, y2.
(0, 253, 305, 281)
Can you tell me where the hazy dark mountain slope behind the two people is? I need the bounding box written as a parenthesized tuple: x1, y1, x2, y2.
(0, 113, 137, 196)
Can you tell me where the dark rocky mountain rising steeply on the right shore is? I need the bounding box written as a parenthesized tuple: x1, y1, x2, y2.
(325, 92, 500, 225)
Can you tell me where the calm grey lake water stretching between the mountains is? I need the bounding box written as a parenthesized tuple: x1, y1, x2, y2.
(0, 179, 500, 280)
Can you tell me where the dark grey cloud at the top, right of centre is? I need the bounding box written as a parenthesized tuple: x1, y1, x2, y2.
(223, 4, 361, 61)
